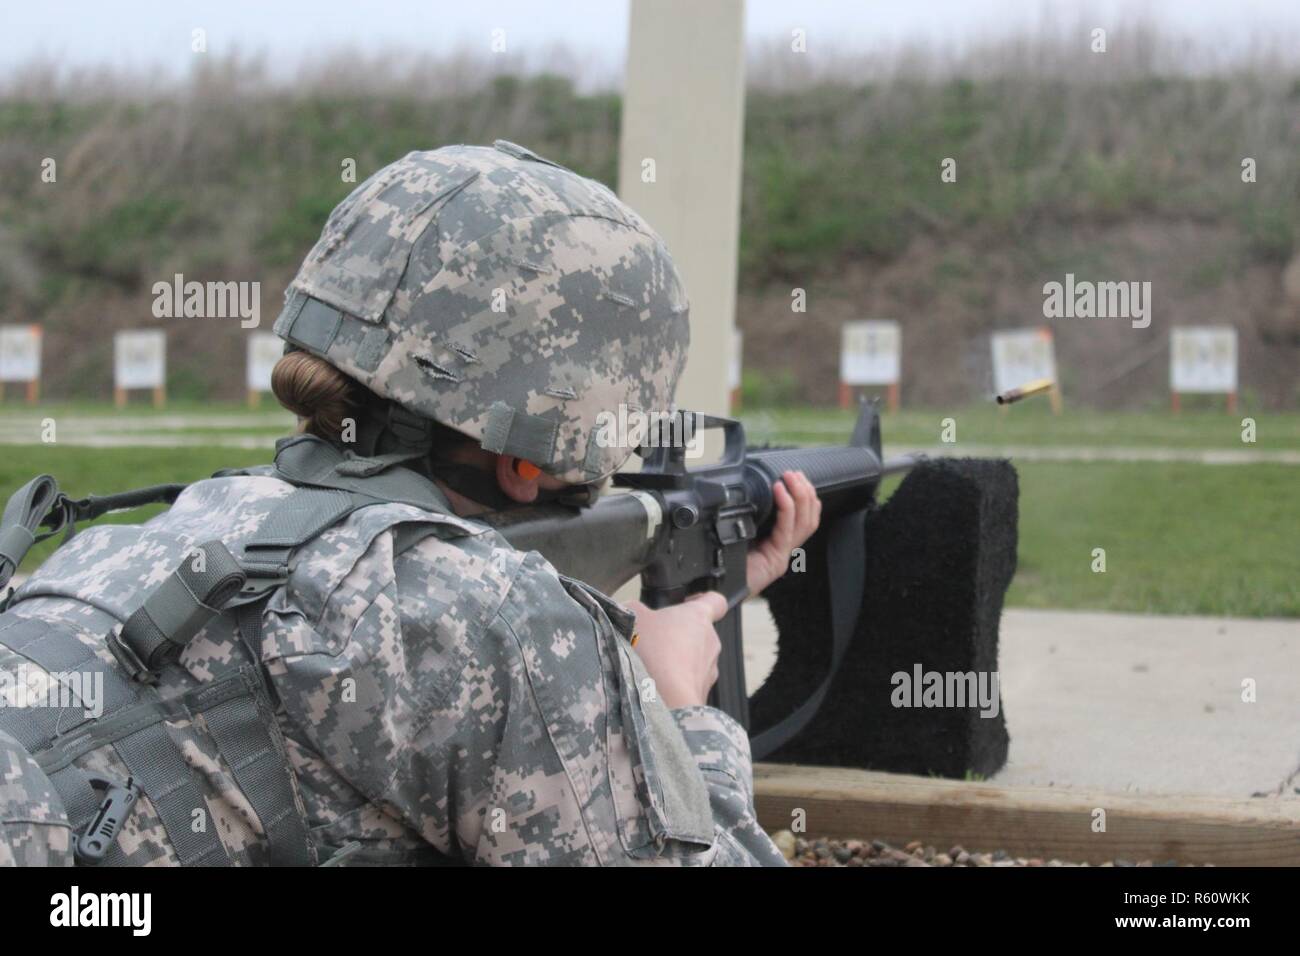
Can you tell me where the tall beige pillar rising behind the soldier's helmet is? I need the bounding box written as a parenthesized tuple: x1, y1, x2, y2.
(619, 0, 745, 415)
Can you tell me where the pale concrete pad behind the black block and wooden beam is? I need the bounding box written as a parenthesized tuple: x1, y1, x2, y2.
(744, 601, 1300, 800)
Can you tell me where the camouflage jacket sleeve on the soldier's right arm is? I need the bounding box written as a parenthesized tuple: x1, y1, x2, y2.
(389, 538, 784, 865)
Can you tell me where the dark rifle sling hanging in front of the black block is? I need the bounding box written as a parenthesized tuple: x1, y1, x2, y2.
(749, 510, 867, 760)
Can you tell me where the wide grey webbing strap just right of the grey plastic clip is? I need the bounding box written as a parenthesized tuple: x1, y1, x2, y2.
(113, 721, 230, 866)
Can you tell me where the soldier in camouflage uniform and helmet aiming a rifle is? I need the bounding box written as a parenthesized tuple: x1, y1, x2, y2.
(0, 142, 820, 865)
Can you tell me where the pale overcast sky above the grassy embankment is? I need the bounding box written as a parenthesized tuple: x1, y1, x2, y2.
(10, 0, 1300, 85)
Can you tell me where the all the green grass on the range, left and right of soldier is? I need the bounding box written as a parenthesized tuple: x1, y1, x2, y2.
(0, 410, 1300, 617)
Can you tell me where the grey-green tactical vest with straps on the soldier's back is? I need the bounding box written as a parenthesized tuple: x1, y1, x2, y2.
(0, 436, 484, 866)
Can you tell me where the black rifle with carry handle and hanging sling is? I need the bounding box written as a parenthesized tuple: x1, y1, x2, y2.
(484, 405, 913, 757)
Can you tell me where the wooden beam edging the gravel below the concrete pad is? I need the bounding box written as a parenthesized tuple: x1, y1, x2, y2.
(754, 763, 1300, 866)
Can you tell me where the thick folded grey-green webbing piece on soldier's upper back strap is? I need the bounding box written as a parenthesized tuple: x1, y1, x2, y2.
(121, 541, 246, 671)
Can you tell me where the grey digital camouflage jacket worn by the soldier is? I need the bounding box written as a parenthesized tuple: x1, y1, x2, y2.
(0, 439, 784, 865)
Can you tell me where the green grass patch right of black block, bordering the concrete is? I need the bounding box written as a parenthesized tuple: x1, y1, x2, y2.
(1006, 462, 1300, 617)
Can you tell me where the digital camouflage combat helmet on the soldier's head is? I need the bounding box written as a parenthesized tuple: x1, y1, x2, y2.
(276, 140, 689, 483)
